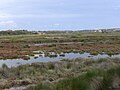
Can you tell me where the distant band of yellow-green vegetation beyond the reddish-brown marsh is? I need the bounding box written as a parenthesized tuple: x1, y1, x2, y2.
(0, 30, 120, 44)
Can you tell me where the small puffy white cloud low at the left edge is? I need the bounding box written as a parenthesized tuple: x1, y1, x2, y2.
(0, 20, 17, 29)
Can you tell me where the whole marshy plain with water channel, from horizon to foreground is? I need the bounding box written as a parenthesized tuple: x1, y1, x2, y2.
(0, 31, 120, 90)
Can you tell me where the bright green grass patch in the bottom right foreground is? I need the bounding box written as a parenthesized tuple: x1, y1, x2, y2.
(28, 66, 120, 90)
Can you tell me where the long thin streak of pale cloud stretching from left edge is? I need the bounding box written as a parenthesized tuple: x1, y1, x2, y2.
(0, 13, 84, 19)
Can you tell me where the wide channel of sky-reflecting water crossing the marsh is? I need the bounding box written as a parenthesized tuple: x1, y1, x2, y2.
(0, 53, 120, 67)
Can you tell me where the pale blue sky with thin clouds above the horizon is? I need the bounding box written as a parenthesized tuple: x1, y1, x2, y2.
(0, 0, 120, 30)
